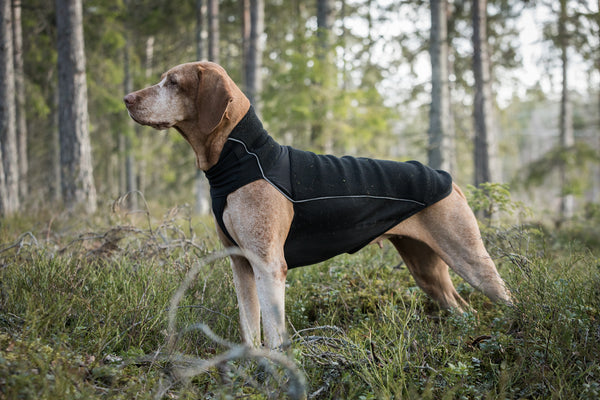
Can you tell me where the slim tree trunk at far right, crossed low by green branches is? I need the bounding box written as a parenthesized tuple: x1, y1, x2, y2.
(558, 0, 575, 219)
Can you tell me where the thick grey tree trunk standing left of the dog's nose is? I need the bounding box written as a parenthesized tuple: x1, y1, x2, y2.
(56, 0, 97, 213)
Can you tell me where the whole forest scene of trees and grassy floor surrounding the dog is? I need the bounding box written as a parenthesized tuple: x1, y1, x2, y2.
(0, 0, 600, 400)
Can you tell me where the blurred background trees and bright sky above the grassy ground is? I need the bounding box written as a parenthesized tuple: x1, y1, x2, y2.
(0, 0, 600, 225)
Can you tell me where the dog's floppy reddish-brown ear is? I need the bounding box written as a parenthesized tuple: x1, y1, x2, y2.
(196, 67, 232, 135)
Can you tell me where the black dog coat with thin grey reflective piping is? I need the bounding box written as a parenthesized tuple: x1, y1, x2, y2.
(206, 107, 452, 268)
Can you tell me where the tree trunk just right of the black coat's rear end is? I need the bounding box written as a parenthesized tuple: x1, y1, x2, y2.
(472, 0, 499, 186)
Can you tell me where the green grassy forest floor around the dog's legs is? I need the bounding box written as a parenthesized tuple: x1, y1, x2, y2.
(0, 202, 600, 399)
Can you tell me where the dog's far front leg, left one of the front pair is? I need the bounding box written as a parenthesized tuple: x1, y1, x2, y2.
(231, 256, 260, 347)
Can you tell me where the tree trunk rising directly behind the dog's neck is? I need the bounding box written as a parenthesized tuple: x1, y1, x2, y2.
(244, 0, 265, 114)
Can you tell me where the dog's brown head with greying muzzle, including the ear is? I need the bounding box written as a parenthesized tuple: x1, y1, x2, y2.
(123, 62, 237, 134)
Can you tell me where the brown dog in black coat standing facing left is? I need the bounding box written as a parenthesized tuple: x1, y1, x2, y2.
(124, 62, 511, 349)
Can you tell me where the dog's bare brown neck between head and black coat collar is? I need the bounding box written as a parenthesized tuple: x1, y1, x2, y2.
(175, 95, 250, 171)
